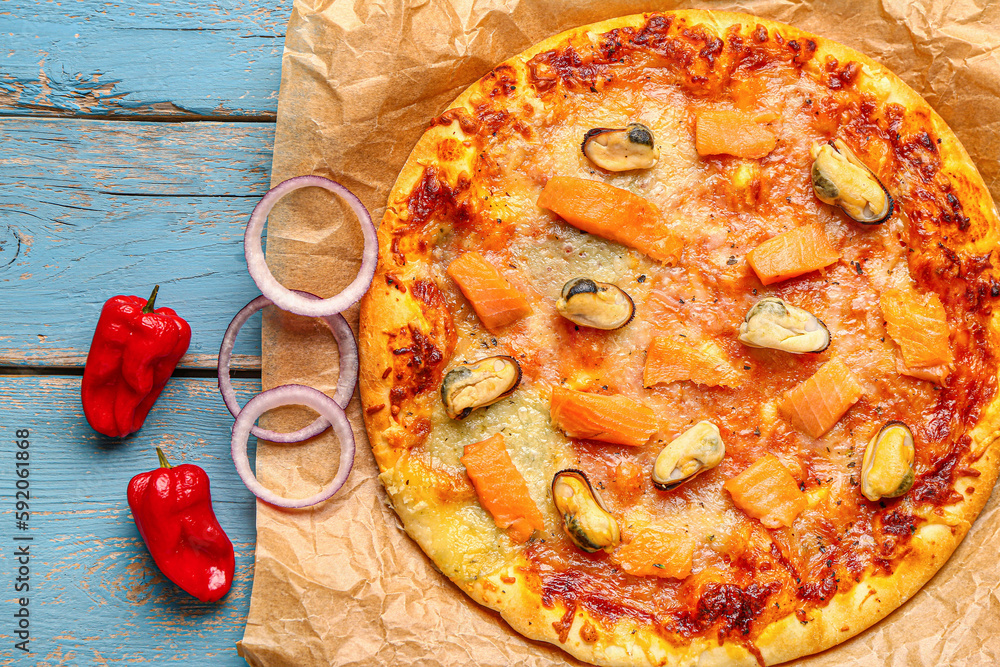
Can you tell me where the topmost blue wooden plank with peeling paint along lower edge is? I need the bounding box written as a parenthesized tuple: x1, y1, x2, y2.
(0, 0, 292, 121)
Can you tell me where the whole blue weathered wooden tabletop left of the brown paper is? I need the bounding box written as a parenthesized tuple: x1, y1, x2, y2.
(0, 0, 291, 666)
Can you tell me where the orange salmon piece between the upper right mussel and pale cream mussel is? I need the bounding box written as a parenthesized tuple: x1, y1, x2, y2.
(747, 225, 840, 285)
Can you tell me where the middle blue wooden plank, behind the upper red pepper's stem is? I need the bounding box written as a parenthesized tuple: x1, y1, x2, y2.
(0, 118, 274, 368)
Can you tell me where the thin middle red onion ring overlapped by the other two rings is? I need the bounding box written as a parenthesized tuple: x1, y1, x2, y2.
(218, 290, 358, 443)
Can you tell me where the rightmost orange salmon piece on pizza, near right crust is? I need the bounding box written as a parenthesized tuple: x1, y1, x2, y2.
(879, 289, 954, 369)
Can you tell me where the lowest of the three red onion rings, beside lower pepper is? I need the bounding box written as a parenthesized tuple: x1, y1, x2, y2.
(232, 384, 354, 509)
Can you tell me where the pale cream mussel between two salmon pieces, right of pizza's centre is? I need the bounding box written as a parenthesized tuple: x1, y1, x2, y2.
(737, 296, 830, 354)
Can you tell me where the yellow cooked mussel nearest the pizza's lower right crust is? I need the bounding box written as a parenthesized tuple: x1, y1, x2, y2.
(861, 421, 916, 502)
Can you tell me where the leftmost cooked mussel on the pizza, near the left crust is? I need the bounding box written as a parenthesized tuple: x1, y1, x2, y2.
(441, 355, 521, 419)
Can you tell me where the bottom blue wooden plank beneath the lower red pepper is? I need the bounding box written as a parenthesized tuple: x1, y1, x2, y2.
(0, 377, 260, 667)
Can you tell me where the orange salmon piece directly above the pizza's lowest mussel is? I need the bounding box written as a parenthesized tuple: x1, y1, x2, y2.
(550, 387, 658, 447)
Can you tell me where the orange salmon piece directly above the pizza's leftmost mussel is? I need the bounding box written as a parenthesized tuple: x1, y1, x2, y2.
(447, 250, 531, 333)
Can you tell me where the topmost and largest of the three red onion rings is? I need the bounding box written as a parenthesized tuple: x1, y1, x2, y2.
(243, 176, 378, 317)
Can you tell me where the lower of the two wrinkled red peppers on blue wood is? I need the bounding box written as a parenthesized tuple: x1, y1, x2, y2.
(128, 447, 236, 602)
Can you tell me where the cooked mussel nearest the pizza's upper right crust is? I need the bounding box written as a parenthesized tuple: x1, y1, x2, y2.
(809, 139, 893, 225)
